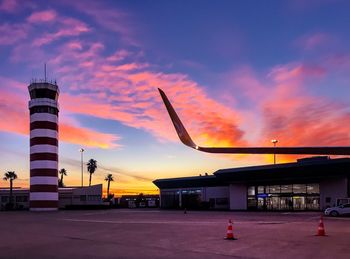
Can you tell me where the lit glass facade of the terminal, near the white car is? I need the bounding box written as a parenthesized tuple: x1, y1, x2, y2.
(247, 183, 320, 211)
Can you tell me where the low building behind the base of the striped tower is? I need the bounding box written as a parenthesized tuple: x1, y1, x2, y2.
(0, 184, 103, 210)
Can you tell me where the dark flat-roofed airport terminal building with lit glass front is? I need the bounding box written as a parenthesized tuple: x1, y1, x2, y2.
(153, 157, 350, 211)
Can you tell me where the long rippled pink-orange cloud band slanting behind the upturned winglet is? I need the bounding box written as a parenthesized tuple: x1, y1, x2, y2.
(45, 41, 244, 148)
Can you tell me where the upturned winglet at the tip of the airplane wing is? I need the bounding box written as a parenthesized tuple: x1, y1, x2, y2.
(158, 88, 198, 149)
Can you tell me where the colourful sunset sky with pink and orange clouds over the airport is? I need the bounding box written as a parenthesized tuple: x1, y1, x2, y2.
(0, 0, 350, 195)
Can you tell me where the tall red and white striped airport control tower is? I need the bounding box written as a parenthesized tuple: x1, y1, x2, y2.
(28, 79, 59, 211)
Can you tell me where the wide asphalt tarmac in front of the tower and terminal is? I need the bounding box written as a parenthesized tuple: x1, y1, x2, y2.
(0, 209, 350, 258)
